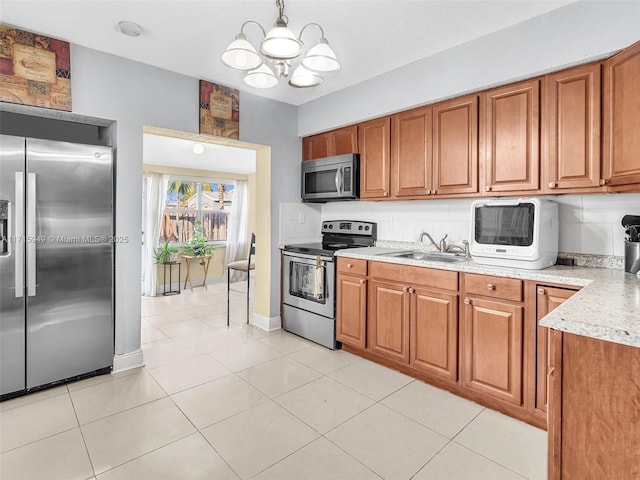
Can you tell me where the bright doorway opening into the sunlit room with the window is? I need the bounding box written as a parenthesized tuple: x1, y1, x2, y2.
(141, 127, 271, 338)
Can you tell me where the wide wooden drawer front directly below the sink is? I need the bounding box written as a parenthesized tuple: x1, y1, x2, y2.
(370, 262, 458, 292)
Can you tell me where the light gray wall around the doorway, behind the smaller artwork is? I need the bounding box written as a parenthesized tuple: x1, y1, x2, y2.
(71, 45, 300, 354)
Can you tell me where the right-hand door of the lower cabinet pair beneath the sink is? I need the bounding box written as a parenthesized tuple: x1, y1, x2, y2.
(409, 289, 458, 382)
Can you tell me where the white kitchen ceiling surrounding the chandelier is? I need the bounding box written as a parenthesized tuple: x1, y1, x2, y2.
(0, 0, 575, 105)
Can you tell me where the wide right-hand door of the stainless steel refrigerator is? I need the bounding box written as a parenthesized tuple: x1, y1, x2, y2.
(25, 139, 114, 388)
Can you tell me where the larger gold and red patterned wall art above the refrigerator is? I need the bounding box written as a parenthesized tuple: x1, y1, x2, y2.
(0, 25, 71, 112)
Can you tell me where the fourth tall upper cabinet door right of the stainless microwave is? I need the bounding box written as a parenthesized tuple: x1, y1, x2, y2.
(483, 79, 540, 193)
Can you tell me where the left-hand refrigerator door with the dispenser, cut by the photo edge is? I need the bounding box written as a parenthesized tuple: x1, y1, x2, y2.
(0, 135, 25, 395)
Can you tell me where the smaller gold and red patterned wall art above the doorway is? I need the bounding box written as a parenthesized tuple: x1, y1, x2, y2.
(200, 80, 240, 140)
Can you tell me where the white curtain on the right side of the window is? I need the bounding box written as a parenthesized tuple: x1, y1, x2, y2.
(224, 180, 249, 282)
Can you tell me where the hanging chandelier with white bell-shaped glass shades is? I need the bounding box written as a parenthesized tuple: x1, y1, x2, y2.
(221, 0, 340, 88)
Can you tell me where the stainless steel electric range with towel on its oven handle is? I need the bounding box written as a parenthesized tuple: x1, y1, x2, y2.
(282, 220, 377, 349)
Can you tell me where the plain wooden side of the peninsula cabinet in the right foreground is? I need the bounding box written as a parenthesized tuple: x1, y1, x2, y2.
(548, 330, 640, 480)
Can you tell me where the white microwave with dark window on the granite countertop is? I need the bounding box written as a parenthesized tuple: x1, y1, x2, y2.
(469, 198, 558, 270)
